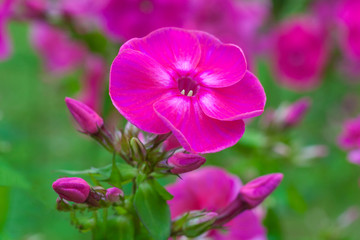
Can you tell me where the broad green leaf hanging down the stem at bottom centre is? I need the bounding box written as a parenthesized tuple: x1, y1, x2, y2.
(134, 180, 171, 240)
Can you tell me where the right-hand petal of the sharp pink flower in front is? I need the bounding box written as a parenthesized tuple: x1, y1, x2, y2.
(198, 72, 266, 121)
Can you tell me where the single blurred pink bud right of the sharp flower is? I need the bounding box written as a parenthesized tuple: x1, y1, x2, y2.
(284, 98, 311, 127)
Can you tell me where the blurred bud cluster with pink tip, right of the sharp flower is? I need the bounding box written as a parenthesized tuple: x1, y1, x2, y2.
(262, 97, 311, 130)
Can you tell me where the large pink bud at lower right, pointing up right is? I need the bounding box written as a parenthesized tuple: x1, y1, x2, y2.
(240, 173, 283, 208)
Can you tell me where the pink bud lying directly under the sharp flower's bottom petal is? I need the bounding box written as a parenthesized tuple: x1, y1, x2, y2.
(167, 153, 206, 174)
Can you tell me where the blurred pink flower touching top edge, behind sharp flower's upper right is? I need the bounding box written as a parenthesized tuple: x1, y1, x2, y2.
(186, 0, 271, 67)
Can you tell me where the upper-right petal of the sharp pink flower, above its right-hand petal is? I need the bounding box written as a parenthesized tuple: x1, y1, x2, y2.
(194, 31, 247, 88)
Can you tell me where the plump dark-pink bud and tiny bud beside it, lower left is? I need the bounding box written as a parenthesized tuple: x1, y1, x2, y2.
(52, 177, 124, 210)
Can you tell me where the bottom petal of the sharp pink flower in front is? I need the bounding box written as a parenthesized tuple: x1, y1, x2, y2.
(154, 95, 245, 153)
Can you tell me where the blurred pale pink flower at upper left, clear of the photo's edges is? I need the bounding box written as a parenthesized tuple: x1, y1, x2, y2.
(30, 22, 87, 75)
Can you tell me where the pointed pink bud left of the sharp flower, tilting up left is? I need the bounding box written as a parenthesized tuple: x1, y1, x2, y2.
(65, 97, 104, 134)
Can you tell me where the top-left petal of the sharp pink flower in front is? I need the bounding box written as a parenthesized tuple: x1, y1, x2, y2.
(120, 28, 201, 72)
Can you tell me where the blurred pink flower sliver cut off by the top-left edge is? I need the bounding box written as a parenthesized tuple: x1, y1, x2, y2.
(0, 0, 15, 61)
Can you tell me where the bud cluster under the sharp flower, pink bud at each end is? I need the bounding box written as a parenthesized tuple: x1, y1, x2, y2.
(65, 98, 206, 174)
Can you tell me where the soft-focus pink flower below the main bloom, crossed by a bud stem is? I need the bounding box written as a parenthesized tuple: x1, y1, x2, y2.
(167, 167, 266, 240)
